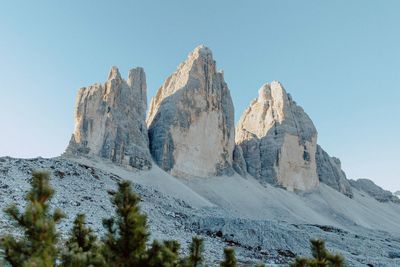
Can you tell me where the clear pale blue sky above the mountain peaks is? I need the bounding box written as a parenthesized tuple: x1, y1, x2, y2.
(0, 0, 400, 190)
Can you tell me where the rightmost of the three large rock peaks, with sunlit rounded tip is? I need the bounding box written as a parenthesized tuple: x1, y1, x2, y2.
(236, 82, 319, 190)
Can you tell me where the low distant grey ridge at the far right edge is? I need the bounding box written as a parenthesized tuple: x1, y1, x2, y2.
(350, 178, 400, 203)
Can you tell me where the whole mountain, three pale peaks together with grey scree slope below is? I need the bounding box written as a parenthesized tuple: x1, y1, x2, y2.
(0, 46, 400, 266)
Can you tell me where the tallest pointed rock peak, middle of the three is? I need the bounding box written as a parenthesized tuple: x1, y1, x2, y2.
(147, 46, 235, 177)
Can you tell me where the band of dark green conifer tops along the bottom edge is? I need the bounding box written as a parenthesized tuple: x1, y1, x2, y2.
(0, 172, 344, 267)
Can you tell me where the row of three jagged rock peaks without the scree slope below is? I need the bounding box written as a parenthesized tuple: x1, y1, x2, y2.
(62, 45, 378, 200)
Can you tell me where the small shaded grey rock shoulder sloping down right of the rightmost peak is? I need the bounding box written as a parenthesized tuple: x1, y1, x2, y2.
(316, 146, 353, 198)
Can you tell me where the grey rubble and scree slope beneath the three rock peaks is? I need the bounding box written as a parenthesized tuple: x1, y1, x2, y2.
(0, 157, 400, 266)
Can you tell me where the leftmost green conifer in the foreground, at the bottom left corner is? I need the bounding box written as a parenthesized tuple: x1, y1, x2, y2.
(1, 172, 64, 267)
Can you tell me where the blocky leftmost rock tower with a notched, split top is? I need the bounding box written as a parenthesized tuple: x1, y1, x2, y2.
(66, 67, 151, 169)
